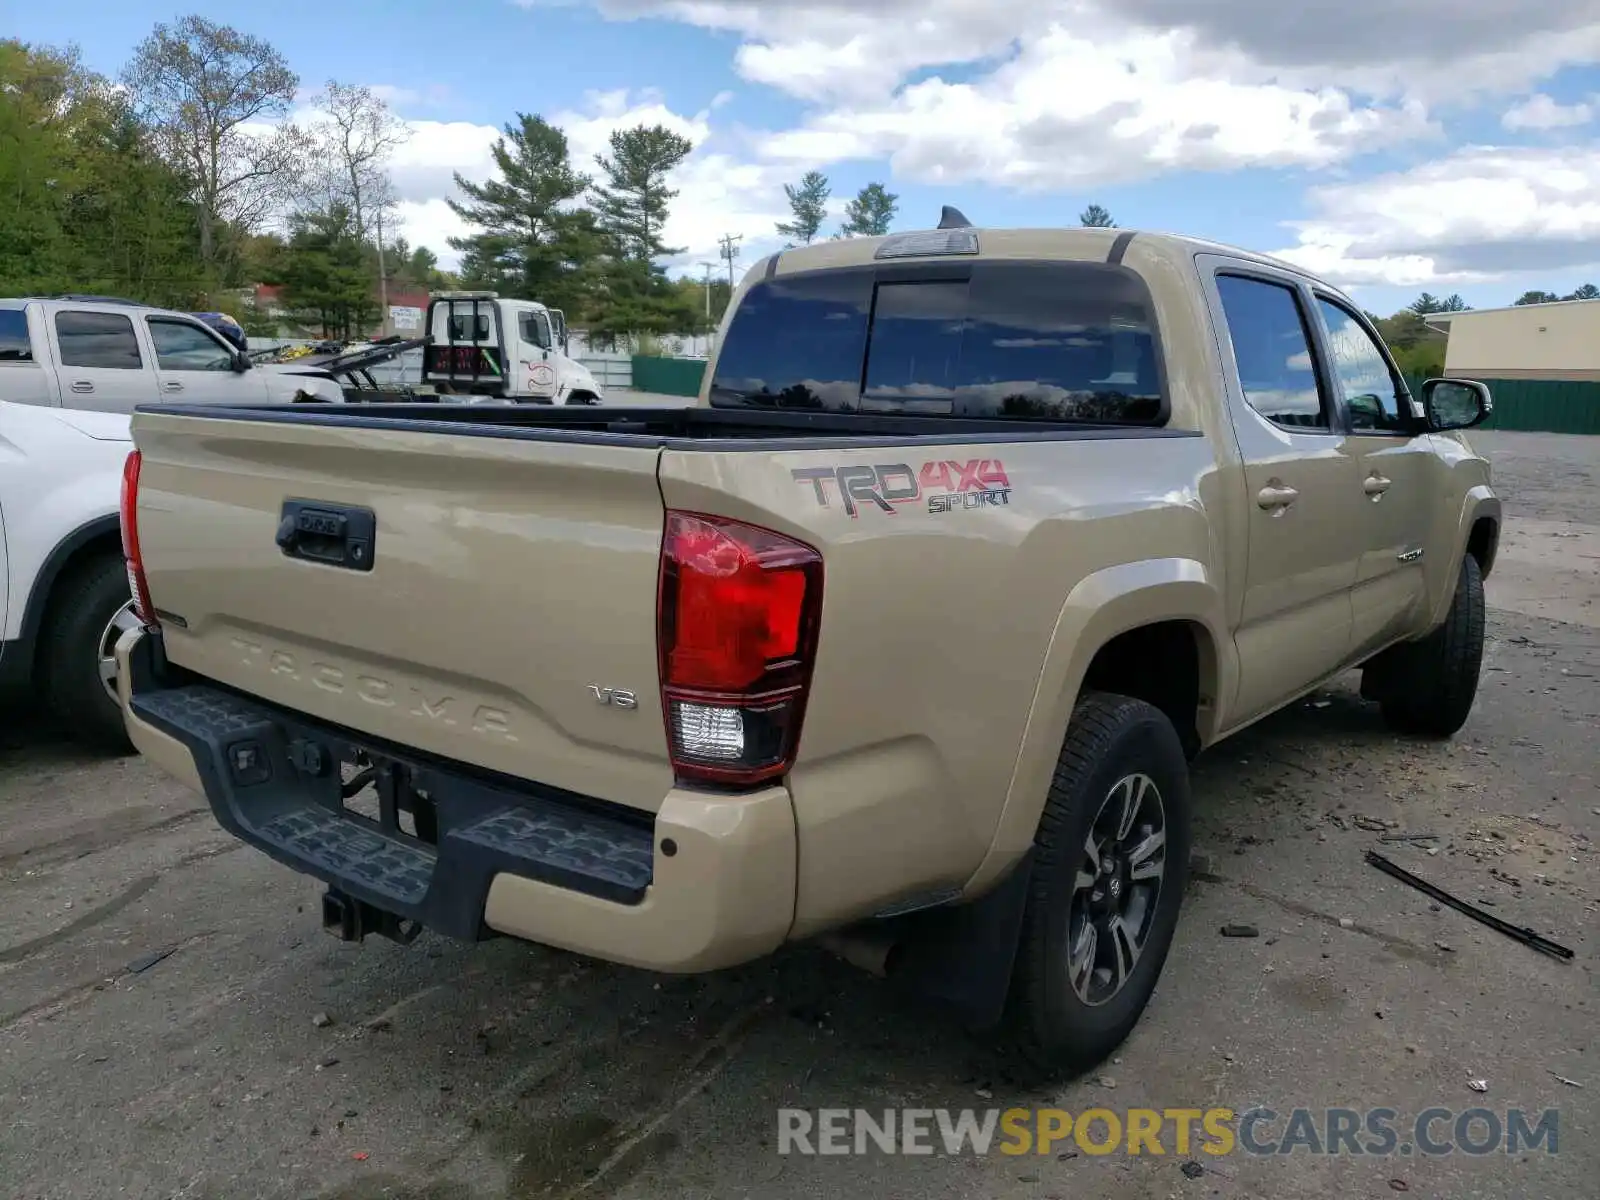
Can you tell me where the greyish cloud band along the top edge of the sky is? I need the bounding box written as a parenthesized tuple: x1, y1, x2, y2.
(556, 0, 1600, 99)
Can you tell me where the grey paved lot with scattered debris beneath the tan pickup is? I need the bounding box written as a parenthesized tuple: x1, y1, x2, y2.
(0, 434, 1600, 1200)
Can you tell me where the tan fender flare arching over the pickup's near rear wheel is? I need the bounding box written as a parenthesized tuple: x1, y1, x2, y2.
(963, 558, 1238, 896)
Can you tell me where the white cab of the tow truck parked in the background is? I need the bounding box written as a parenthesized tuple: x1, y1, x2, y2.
(422, 291, 605, 405)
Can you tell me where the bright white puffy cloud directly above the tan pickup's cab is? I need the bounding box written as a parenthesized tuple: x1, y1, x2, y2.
(762, 27, 1438, 190)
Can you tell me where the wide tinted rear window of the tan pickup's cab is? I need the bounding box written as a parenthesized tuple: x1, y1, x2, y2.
(712, 264, 1165, 424)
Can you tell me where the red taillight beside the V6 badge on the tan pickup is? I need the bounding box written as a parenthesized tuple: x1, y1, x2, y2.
(656, 512, 822, 786)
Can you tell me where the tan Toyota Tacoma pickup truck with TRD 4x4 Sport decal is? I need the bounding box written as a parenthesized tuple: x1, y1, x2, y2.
(118, 213, 1501, 1070)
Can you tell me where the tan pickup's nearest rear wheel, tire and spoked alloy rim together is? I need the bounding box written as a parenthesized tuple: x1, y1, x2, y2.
(1008, 693, 1189, 1074)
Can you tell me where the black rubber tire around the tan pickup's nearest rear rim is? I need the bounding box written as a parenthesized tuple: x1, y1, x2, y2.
(1008, 693, 1190, 1075)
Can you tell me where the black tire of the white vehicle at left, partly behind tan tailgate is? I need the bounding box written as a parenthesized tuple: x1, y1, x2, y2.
(40, 554, 133, 754)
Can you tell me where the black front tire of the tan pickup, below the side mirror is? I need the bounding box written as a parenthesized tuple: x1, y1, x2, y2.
(1374, 554, 1485, 738)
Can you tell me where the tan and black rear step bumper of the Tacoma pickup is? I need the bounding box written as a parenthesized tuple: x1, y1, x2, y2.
(117, 634, 795, 973)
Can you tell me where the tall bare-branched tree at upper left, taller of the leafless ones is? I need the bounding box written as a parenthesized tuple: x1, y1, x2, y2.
(123, 16, 304, 267)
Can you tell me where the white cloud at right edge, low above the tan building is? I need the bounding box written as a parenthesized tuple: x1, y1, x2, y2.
(1274, 142, 1600, 286)
